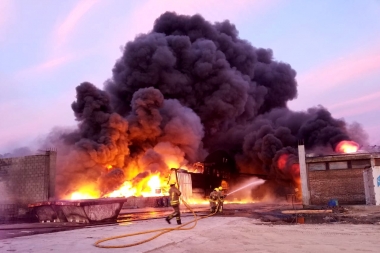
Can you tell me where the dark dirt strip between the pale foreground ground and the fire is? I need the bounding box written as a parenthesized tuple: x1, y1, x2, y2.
(0, 203, 380, 240)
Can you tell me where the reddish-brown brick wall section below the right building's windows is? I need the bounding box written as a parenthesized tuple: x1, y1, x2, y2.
(308, 169, 365, 205)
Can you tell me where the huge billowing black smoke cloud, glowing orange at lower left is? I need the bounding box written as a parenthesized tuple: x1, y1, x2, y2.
(47, 12, 366, 198)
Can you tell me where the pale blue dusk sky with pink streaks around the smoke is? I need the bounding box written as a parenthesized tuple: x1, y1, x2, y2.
(0, 0, 380, 154)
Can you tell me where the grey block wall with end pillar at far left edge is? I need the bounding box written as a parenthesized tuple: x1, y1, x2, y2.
(0, 151, 56, 206)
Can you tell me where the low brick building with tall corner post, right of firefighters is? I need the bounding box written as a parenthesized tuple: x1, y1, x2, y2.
(298, 145, 380, 206)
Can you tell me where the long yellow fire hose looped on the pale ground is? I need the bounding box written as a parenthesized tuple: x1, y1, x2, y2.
(94, 198, 219, 249)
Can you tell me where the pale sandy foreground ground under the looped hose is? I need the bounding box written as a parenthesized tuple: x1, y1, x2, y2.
(0, 216, 380, 253)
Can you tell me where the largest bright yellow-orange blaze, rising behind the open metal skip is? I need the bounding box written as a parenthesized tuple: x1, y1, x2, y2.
(65, 142, 193, 199)
